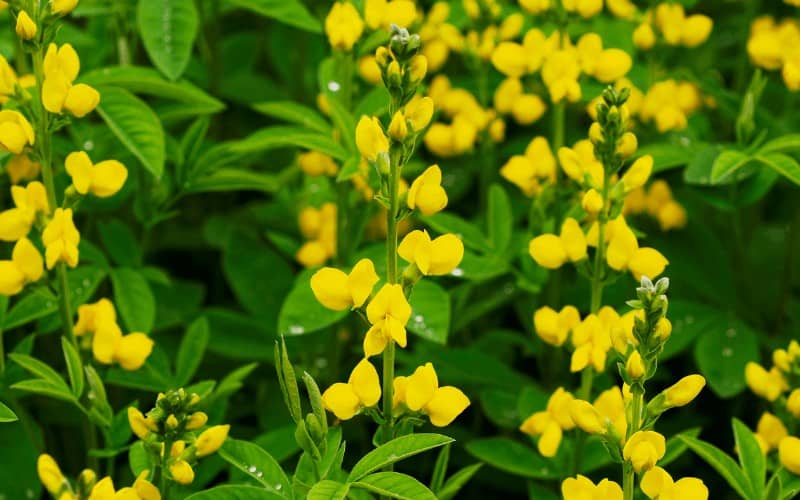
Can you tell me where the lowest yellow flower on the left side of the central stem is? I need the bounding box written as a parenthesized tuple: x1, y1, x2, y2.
(322, 358, 381, 420)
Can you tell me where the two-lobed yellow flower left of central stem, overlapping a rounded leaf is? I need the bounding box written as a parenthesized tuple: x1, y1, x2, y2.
(311, 259, 380, 311)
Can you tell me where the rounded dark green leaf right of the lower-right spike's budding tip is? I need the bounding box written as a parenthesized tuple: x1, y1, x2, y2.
(694, 321, 758, 398)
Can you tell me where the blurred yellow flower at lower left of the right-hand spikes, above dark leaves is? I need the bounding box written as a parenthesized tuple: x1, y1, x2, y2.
(519, 387, 575, 457)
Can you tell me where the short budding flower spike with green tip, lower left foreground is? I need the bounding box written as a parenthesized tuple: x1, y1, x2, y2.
(128, 389, 230, 484)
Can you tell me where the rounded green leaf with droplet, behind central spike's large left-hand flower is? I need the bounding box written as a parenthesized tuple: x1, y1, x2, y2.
(278, 270, 347, 336)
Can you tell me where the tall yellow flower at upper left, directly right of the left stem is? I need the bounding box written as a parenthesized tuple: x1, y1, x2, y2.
(42, 43, 100, 118)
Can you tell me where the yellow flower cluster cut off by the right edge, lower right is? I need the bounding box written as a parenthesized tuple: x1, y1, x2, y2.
(745, 340, 800, 475)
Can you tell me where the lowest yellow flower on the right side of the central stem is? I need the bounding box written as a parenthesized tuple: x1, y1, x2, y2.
(400, 363, 470, 427)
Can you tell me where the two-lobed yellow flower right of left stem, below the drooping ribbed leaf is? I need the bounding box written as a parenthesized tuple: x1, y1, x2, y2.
(65, 151, 128, 198)
